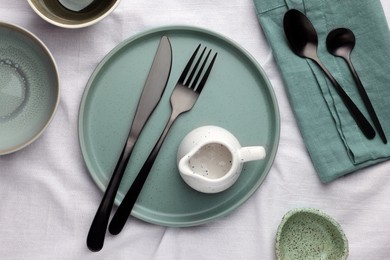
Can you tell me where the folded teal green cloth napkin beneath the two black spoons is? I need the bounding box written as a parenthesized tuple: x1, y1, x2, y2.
(254, 0, 390, 183)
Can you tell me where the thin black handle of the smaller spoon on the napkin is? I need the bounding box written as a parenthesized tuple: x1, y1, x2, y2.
(344, 58, 387, 144)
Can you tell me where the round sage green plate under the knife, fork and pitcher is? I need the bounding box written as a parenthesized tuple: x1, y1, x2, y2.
(79, 26, 280, 227)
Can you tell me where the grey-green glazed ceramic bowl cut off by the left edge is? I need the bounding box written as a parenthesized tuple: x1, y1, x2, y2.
(0, 22, 60, 155)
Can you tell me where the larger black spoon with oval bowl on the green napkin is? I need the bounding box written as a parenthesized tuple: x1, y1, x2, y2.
(283, 9, 375, 139)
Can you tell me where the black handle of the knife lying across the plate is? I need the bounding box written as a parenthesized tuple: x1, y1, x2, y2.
(87, 138, 135, 252)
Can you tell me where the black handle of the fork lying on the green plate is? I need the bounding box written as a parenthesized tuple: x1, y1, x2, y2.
(108, 113, 178, 235)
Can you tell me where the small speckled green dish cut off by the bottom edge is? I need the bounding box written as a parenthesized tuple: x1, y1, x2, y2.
(276, 208, 348, 260)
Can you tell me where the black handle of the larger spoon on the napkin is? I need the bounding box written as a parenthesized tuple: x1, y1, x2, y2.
(311, 57, 375, 139)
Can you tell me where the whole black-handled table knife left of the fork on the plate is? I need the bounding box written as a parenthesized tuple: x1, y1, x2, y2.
(87, 36, 172, 252)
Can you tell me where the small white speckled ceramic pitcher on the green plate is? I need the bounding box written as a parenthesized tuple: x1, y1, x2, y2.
(177, 126, 266, 193)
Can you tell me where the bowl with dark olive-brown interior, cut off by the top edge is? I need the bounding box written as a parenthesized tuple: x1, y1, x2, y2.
(27, 0, 120, 29)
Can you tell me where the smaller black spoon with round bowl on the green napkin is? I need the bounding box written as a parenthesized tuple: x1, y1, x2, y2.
(326, 28, 387, 144)
